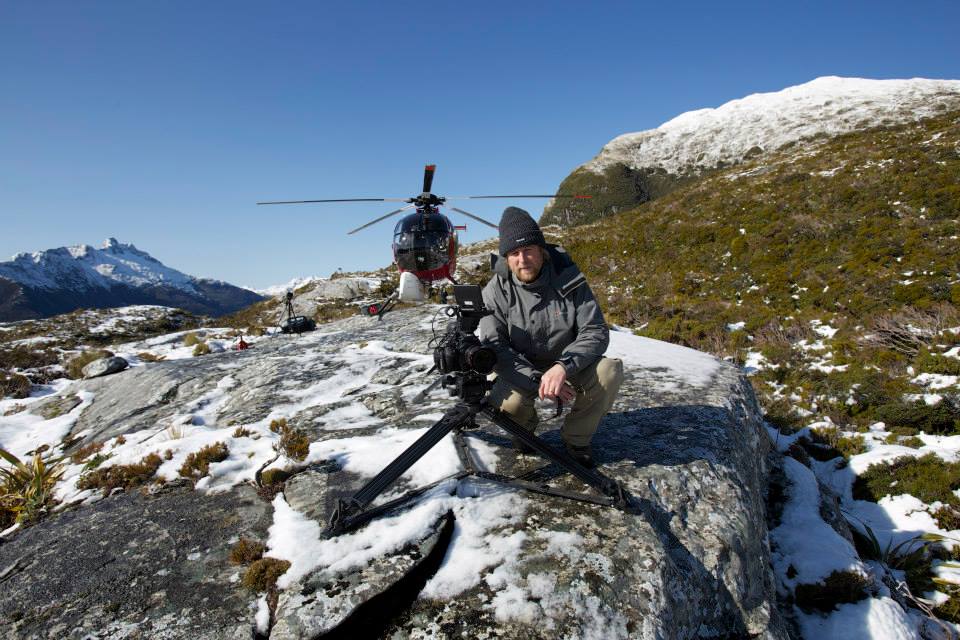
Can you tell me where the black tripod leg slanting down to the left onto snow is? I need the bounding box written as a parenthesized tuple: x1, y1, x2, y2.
(325, 404, 473, 535)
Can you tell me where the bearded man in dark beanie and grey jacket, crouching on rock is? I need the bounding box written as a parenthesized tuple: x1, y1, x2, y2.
(480, 207, 623, 467)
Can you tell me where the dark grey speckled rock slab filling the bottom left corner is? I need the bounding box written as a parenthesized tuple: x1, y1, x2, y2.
(0, 487, 270, 640)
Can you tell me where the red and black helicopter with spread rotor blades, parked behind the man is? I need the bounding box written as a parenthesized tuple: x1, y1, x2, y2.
(257, 164, 591, 318)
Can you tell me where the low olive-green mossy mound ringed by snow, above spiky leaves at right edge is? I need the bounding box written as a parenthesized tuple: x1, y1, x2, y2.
(853, 453, 960, 505)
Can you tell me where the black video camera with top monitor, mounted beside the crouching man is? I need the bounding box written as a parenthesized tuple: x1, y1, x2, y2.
(433, 284, 497, 402)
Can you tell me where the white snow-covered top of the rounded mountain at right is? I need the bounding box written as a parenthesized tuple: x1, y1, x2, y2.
(583, 76, 960, 174)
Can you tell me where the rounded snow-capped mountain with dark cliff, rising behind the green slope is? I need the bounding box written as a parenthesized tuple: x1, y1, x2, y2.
(540, 77, 960, 225)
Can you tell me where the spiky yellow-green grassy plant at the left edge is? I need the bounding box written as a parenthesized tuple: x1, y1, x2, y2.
(0, 449, 64, 529)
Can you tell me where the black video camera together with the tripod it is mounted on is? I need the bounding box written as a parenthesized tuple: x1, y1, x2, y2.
(324, 285, 635, 537)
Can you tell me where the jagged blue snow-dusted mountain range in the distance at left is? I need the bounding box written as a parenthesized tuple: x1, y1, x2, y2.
(0, 238, 263, 322)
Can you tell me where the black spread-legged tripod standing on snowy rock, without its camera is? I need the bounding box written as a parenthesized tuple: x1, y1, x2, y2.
(324, 372, 633, 537)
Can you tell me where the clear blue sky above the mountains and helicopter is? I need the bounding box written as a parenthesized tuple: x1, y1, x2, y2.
(0, 0, 960, 286)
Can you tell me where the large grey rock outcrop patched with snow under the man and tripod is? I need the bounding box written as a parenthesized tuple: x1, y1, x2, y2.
(0, 307, 789, 638)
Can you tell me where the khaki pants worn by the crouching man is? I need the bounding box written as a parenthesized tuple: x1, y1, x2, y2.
(490, 358, 623, 447)
